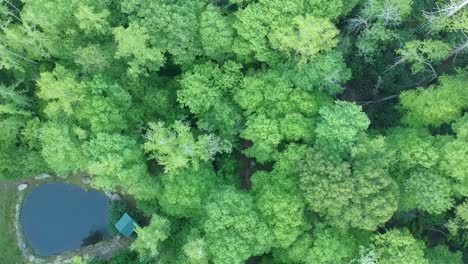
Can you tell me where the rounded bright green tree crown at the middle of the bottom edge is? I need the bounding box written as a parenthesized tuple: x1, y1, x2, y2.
(203, 187, 273, 264)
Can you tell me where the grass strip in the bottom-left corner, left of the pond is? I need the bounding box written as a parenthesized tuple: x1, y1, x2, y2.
(0, 186, 25, 264)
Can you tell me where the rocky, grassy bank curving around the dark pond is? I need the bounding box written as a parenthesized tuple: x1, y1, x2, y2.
(13, 175, 133, 263)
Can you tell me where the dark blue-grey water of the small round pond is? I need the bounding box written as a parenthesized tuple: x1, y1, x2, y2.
(20, 183, 109, 256)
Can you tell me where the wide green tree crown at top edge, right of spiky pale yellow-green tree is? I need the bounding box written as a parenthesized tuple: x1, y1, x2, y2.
(121, 0, 206, 66)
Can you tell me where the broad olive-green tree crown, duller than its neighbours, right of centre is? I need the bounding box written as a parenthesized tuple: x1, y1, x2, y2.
(300, 138, 398, 230)
